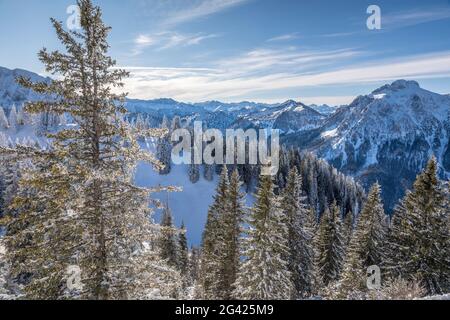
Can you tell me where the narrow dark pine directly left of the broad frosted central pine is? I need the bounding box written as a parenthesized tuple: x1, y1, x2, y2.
(219, 169, 245, 300)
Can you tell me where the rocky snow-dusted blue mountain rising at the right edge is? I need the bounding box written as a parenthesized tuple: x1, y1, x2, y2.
(284, 80, 450, 209)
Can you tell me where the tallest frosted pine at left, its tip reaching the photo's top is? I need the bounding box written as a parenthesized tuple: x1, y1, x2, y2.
(0, 0, 177, 299)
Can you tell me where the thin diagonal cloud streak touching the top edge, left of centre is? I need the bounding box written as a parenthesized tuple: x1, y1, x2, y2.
(165, 0, 251, 25)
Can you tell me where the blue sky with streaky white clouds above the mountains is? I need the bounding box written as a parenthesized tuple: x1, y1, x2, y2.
(0, 0, 450, 105)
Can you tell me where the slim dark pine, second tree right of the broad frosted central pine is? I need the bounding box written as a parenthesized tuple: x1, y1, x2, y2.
(316, 203, 345, 286)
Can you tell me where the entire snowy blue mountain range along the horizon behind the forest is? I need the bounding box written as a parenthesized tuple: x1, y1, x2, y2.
(0, 67, 450, 209)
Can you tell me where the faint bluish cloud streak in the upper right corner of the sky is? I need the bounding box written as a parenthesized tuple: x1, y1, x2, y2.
(382, 5, 450, 28)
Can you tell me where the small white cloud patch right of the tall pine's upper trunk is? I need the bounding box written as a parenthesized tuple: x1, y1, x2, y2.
(131, 31, 219, 56)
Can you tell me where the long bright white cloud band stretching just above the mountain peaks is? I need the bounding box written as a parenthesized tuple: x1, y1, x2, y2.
(118, 51, 450, 103)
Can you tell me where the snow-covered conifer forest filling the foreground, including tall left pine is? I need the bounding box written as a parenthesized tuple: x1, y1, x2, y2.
(0, 0, 450, 300)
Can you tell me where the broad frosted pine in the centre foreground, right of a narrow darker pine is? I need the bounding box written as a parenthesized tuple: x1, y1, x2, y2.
(234, 175, 293, 300)
